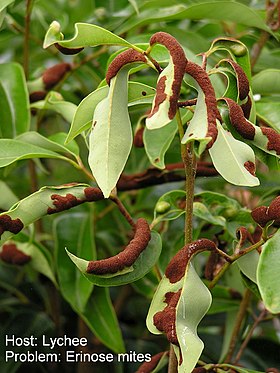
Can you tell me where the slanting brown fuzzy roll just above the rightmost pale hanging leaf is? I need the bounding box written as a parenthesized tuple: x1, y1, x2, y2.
(223, 98, 256, 140)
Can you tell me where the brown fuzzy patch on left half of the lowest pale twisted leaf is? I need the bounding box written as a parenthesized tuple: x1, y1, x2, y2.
(153, 289, 182, 346)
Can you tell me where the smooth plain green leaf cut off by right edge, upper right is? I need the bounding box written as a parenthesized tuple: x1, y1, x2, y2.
(252, 69, 280, 96)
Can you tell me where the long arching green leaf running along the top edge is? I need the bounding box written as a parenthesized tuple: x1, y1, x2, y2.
(115, 1, 271, 34)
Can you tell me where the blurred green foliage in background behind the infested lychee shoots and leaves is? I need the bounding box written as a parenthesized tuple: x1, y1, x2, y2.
(0, 0, 280, 373)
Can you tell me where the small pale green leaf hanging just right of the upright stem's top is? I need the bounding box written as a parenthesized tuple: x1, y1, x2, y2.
(182, 87, 212, 157)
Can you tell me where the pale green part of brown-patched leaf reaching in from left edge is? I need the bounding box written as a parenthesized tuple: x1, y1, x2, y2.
(0, 184, 92, 245)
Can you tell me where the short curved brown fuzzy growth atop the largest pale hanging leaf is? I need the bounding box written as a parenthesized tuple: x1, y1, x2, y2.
(106, 49, 147, 85)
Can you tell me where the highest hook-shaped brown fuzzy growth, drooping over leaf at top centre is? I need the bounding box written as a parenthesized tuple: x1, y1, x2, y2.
(150, 32, 188, 119)
